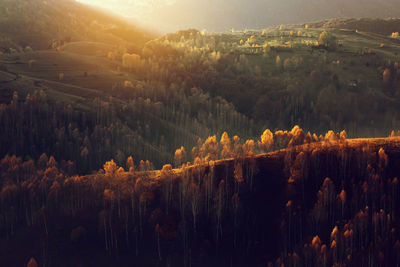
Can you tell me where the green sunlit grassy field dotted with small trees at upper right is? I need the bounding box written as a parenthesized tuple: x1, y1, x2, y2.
(228, 28, 400, 88)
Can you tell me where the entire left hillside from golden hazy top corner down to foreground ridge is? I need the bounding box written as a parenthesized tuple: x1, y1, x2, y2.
(0, 0, 254, 173)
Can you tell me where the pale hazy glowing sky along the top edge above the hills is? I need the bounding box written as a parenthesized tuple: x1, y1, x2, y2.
(77, 0, 400, 32)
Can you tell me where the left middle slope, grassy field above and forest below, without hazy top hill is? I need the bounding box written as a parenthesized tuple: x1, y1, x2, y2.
(0, 42, 253, 172)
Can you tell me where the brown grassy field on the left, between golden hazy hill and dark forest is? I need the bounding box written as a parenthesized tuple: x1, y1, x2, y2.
(0, 43, 134, 105)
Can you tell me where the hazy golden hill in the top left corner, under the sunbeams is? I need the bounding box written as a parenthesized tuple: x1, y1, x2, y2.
(0, 0, 153, 52)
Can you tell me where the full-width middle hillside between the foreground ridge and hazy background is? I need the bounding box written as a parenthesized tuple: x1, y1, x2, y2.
(0, 18, 400, 174)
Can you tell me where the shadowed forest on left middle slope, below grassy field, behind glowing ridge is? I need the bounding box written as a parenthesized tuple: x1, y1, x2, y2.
(0, 87, 252, 173)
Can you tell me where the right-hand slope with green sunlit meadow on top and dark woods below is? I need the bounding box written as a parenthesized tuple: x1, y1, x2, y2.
(159, 25, 400, 137)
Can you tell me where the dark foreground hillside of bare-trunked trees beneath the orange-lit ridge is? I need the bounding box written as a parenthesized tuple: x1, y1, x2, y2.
(0, 137, 400, 266)
